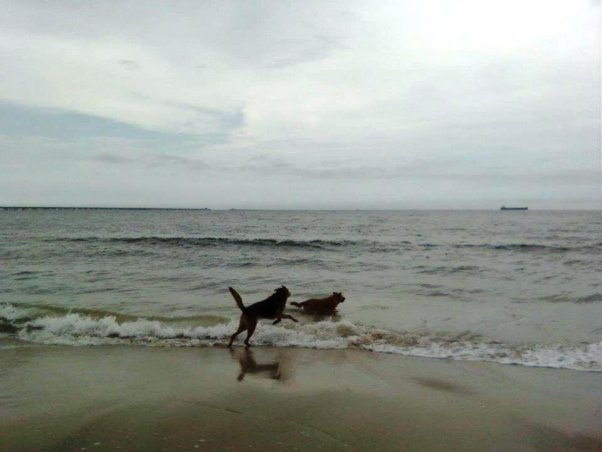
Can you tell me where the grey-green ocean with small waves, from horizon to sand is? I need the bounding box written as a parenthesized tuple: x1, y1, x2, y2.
(0, 209, 602, 371)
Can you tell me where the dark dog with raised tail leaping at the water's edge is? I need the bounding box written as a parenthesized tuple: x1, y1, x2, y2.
(228, 286, 297, 347)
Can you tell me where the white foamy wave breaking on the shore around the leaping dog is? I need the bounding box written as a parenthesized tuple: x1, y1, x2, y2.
(0, 304, 602, 372)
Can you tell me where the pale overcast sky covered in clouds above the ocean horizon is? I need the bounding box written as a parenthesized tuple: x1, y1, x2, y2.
(0, 0, 600, 209)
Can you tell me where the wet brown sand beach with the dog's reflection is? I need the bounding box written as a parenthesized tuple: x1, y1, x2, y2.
(0, 346, 602, 451)
